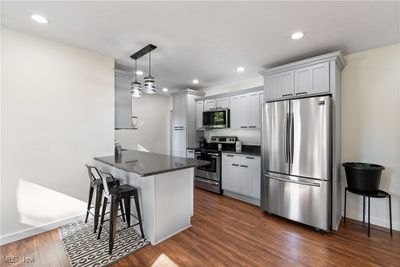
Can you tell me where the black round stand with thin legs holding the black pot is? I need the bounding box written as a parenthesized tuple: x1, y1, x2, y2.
(343, 187, 393, 236)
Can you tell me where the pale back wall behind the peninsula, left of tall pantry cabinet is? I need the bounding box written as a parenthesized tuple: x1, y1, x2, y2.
(115, 94, 172, 154)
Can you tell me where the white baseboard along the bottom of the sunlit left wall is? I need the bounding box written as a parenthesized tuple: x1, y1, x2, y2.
(0, 214, 84, 246)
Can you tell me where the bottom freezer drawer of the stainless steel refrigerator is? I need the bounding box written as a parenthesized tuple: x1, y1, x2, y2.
(263, 172, 331, 231)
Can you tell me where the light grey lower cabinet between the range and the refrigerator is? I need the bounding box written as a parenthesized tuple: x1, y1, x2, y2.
(222, 153, 261, 202)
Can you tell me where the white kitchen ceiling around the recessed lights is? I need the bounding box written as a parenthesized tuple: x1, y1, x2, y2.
(1, 1, 400, 93)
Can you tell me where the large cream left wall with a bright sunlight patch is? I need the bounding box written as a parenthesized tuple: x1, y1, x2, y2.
(0, 28, 114, 245)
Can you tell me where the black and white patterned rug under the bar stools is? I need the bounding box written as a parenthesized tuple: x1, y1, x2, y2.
(58, 220, 150, 267)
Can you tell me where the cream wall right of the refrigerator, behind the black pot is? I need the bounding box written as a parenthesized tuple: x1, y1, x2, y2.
(342, 44, 400, 230)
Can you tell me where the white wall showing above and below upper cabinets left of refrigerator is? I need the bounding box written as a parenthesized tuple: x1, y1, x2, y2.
(202, 75, 264, 145)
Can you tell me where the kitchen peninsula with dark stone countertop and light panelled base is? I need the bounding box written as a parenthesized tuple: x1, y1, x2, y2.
(94, 150, 209, 245)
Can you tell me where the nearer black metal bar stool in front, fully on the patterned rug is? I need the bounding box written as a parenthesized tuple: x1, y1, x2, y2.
(97, 173, 144, 254)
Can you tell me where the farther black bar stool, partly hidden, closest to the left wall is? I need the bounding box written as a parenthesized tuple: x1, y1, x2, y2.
(85, 164, 125, 233)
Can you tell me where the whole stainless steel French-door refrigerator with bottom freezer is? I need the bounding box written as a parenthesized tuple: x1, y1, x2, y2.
(261, 96, 332, 231)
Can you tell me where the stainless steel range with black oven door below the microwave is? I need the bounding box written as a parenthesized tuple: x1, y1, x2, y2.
(194, 136, 237, 194)
